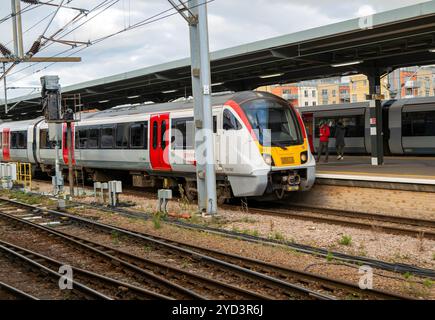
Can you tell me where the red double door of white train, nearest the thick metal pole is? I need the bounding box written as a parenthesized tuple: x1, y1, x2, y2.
(149, 113, 171, 171)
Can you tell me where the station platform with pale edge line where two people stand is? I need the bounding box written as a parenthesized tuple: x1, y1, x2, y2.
(316, 155, 435, 192)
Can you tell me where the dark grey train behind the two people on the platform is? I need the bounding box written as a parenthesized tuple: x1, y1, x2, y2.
(299, 97, 435, 155)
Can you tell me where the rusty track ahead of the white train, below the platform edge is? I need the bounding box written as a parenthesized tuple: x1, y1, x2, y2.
(228, 202, 435, 240)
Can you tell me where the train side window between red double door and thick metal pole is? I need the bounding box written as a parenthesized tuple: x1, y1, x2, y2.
(171, 117, 195, 150)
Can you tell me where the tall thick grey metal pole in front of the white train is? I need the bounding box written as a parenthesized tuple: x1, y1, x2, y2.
(189, 0, 217, 215)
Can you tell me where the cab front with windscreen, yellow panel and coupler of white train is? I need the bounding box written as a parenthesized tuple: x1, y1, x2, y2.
(241, 91, 316, 199)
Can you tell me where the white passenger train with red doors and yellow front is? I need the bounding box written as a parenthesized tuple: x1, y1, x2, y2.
(0, 91, 315, 202)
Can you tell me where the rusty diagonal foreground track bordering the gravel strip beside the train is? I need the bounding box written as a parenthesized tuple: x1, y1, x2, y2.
(0, 199, 407, 299)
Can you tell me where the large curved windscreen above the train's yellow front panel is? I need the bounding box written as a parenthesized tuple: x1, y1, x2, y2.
(241, 99, 303, 147)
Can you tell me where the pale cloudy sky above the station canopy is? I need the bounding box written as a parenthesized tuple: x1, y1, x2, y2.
(0, 0, 425, 98)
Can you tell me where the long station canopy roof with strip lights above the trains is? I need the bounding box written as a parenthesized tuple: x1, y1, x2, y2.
(0, 1, 435, 119)
